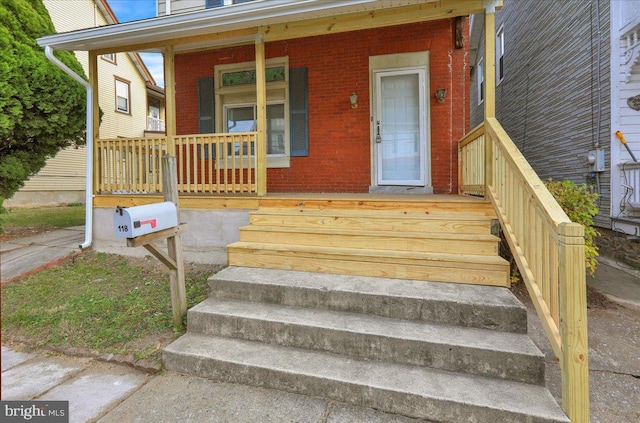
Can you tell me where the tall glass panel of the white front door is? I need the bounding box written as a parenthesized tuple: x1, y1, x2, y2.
(378, 73, 422, 184)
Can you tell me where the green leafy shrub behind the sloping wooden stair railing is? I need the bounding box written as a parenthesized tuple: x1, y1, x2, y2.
(545, 179, 600, 276)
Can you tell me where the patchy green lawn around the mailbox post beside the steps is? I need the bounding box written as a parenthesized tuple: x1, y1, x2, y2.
(2, 251, 222, 360)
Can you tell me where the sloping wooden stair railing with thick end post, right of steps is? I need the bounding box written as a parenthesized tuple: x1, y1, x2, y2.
(458, 118, 589, 422)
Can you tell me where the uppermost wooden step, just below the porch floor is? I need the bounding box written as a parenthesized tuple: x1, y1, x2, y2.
(249, 208, 491, 234)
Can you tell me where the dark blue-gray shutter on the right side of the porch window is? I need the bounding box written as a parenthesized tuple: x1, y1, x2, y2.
(289, 68, 309, 157)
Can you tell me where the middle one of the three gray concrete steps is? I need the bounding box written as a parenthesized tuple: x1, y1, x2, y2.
(188, 298, 545, 384)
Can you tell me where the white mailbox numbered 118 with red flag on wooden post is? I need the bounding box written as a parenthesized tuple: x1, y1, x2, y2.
(113, 201, 178, 238)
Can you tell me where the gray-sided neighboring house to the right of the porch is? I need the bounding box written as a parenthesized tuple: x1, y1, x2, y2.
(470, 0, 640, 266)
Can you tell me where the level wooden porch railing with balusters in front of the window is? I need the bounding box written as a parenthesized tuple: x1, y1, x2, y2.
(94, 132, 259, 194)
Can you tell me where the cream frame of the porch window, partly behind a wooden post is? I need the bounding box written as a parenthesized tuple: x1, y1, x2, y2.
(214, 56, 291, 168)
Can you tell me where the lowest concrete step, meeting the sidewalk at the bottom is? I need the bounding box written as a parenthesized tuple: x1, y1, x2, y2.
(163, 333, 569, 423)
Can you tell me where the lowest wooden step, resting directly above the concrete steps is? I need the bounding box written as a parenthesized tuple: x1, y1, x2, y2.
(227, 241, 509, 286)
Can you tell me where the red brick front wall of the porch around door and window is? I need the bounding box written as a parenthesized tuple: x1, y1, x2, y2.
(176, 20, 469, 193)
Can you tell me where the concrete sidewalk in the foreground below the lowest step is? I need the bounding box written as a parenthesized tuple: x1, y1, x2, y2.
(2, 347, 421, 423)
